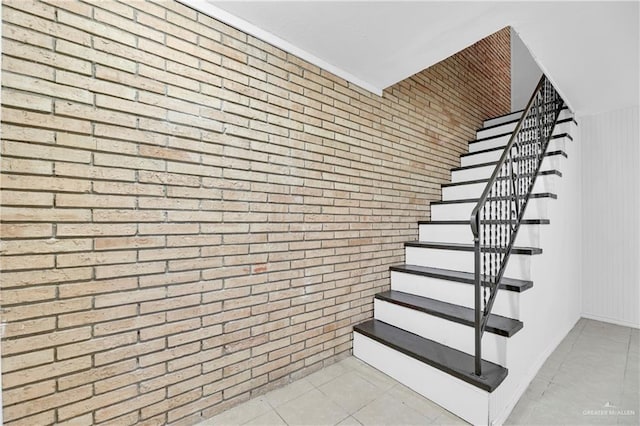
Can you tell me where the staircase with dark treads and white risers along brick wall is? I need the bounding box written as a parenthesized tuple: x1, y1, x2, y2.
(353, 79, 579, 424)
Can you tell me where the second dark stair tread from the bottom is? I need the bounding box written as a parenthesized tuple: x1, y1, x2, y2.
(375, 290, 522, 337)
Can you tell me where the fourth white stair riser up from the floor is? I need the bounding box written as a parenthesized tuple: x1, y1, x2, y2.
(405, 246, 532, 280)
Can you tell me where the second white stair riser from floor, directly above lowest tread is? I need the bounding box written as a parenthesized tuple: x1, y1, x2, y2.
(373, 299, 508, 367)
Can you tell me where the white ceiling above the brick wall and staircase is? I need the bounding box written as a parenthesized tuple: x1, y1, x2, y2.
(181, 0, 640, 115)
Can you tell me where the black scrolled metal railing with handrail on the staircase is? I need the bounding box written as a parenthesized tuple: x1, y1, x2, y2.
(471, 75, 564, 376)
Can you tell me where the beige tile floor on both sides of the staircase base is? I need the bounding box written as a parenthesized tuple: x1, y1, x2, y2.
(199, 319, 640, 426)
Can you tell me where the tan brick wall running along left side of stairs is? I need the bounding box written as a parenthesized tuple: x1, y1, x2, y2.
(1, 0, 510, 425)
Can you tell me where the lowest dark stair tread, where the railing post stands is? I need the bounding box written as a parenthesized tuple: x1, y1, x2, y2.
(353, 319, 508, 392)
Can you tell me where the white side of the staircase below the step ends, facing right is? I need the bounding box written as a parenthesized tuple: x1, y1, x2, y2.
(489, 119, 582, 424)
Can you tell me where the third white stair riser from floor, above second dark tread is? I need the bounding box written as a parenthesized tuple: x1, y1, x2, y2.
(391, 271, 520, 319)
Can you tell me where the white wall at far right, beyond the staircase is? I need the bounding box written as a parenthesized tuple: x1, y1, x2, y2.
(579, 106, 640, 327)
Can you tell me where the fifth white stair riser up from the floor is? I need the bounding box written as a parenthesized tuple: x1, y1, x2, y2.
(418, 224, 546, 248)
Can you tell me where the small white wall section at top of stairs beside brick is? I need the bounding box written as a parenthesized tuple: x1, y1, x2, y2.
(511, 28, 542, 111)
